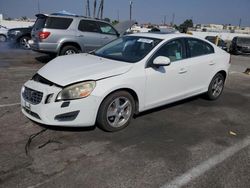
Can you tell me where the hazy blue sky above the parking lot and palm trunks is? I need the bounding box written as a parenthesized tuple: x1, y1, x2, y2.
(0, 0, 250, 26)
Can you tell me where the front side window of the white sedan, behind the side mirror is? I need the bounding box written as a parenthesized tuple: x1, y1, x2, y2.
(150, 39, 186, 63)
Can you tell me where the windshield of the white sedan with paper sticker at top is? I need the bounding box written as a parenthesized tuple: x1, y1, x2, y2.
(94, 36, 162, 63)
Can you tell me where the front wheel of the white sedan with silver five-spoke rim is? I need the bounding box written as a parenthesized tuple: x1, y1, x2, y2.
(96, 91, 135, 132)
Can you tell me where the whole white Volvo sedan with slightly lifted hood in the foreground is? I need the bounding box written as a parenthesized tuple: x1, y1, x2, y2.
(21, 33, 230, 131)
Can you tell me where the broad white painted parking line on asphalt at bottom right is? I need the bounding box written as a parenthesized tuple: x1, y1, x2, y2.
(161, 137, 250, 188)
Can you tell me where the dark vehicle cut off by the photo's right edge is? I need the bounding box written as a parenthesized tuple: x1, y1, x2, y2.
(230, 37, 250, 55)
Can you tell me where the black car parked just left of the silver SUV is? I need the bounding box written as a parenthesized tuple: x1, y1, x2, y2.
(8, 27, 32, 49)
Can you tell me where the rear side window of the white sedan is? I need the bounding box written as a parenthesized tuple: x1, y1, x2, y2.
(187, 39, 214, 57)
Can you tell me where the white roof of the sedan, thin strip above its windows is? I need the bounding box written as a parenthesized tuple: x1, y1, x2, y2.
(131, 33, 197, 40)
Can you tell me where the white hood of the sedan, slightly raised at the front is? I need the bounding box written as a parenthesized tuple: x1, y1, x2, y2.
(38, 54, 132, 86)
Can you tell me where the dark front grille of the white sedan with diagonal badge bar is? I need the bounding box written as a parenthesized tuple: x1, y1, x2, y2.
(23, 87, 43, 104)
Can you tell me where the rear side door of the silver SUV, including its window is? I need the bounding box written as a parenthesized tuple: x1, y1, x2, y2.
(77, 19, 103, 52)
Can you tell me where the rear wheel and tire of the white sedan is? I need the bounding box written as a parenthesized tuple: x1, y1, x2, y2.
(206, 73, 225, 100)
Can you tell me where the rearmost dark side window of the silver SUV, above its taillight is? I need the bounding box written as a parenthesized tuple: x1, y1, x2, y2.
(45, 17, 73, 29)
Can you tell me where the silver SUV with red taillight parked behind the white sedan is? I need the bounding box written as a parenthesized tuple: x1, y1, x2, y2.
(30, 14, 135, 55)
